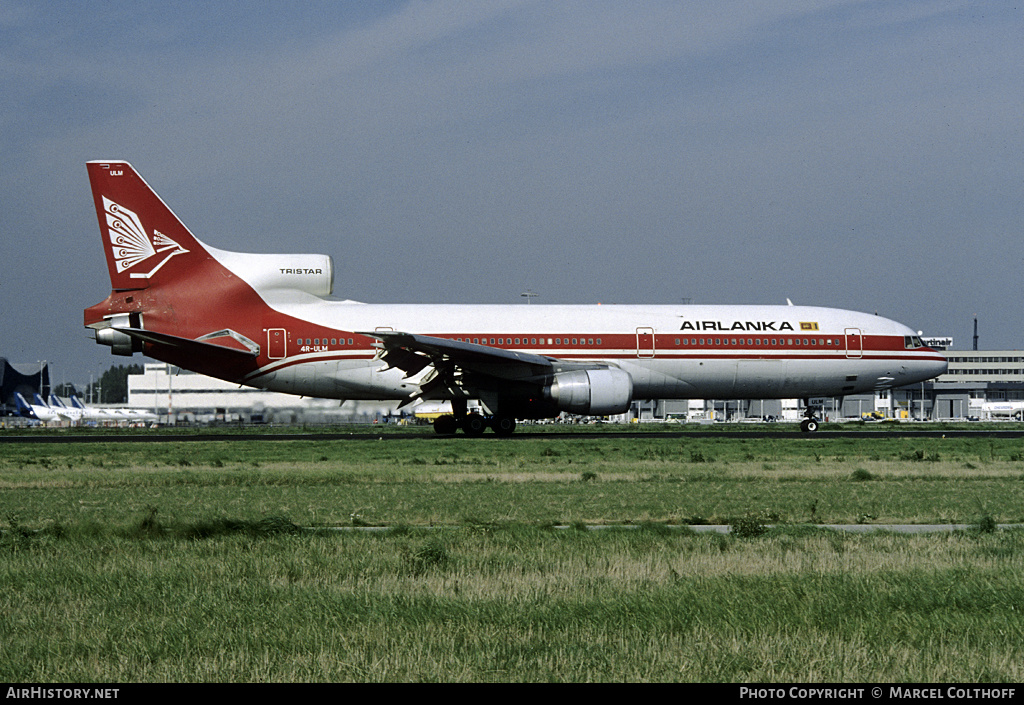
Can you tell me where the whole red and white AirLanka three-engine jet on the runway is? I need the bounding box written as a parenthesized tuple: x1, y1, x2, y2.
(84, 160, 946, 436)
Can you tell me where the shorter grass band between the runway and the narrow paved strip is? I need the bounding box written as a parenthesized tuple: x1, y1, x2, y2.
(0, 436, 1024, 528)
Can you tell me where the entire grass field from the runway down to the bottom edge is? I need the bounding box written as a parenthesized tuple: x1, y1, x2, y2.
(0, 426, 1024, 682)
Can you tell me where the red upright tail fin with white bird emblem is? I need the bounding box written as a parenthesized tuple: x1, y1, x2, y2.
(86, 161, 207, 291)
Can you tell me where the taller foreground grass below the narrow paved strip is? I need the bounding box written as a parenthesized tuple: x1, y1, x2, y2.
(0, 526, 1024, 682)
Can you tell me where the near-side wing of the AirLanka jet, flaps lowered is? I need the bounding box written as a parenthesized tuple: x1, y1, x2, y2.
(359, 331, 557, 406)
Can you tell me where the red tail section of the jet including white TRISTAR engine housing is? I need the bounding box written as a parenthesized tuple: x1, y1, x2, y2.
(84, 160, 334, 379)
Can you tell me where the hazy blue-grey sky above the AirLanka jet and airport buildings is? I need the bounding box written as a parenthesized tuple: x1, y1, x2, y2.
(0, 0, 1024, 384)
